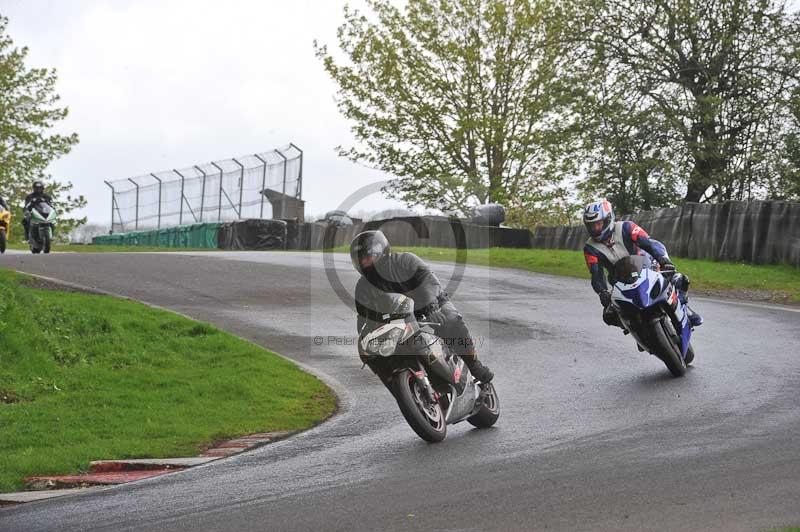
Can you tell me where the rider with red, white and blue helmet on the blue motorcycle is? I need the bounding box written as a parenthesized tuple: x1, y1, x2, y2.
(583, 200, 703, 327)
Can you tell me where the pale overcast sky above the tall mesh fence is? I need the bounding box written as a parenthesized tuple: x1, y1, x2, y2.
(0, 0, 398, 222)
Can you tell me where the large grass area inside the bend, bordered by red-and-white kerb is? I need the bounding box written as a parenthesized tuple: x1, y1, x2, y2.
(0, 269, 336, 492)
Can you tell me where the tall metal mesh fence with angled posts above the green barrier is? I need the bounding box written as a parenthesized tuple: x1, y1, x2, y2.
(105, 144, 303, 233)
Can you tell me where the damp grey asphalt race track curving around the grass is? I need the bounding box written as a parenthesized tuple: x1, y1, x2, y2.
(0, 252, 800, 532)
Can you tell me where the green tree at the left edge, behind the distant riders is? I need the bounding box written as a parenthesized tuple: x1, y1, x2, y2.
(0, 16, 86, 241)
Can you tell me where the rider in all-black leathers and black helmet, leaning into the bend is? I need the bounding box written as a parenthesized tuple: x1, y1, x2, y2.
(350, 231, 494, 383)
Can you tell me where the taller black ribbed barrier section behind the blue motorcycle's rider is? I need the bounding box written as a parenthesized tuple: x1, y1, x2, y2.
(532, 201, 800, 267)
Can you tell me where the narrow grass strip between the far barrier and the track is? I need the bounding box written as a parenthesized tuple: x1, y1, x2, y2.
(402, 247, 800, 304)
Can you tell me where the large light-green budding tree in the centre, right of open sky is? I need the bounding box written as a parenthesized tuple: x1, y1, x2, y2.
(315, 0, 574, 220)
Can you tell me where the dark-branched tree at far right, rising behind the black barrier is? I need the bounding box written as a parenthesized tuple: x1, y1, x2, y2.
(576, 0, 800, 206)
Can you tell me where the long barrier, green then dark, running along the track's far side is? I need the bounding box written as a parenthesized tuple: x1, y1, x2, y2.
(92, 201, 800, 267)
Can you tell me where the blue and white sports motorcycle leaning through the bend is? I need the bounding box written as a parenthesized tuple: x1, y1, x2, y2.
(611, 255, 694, 377)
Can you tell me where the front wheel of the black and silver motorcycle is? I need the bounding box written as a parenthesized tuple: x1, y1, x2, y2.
(392, 369, 447, 443)
